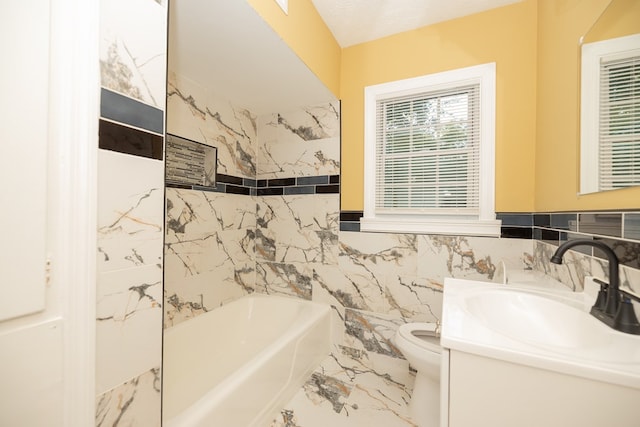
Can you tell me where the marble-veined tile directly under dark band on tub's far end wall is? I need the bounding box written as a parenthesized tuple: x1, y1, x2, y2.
(257, 194, 340, 264)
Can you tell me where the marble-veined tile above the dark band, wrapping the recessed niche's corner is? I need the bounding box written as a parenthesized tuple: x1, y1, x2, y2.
(167, 73, 257, 178)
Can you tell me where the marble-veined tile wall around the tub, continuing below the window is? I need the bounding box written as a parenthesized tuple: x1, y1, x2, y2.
(165, 74, 533, 357)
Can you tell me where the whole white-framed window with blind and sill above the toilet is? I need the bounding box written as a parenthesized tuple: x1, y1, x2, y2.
(361, 63, 500, 235)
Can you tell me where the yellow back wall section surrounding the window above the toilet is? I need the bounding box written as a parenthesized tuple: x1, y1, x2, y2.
(340, 0, 536, 212)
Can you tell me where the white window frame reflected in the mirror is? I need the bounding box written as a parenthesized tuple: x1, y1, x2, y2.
(580, 34, 640, 194)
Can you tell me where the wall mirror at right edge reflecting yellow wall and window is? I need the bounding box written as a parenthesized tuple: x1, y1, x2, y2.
(580, 0, 640, 194)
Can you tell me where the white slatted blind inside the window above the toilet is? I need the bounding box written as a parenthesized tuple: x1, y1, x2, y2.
(375, 84, 480, 215)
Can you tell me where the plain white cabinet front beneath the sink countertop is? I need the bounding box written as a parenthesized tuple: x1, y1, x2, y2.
(441, 349, 640, 427)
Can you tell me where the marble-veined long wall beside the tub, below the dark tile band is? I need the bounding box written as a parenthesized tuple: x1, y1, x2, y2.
(164, 188, 256, 327)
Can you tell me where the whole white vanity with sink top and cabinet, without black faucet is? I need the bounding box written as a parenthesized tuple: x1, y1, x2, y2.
(440, 277, 640, 427)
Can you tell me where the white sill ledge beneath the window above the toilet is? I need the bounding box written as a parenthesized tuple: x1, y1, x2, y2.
(360, 217, 502, 237)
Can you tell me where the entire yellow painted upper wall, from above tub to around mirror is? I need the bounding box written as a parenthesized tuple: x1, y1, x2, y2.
(247, 0, 640, 212)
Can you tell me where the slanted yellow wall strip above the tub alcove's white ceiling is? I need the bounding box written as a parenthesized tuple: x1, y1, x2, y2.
(247, 0, 341, 98)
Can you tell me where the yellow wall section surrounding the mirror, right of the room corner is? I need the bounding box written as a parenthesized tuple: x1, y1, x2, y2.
(535, 0, 640, 212)
